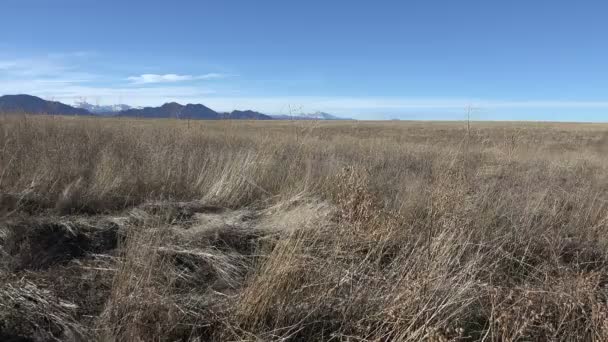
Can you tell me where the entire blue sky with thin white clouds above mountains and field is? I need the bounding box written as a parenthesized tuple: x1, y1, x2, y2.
(0, 0, 608, 121)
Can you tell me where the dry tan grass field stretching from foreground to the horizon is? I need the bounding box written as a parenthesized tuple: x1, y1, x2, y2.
(0, 116, 608, 341)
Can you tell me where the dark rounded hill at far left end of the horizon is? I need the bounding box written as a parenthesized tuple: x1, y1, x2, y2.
(0, 95, 91, 115)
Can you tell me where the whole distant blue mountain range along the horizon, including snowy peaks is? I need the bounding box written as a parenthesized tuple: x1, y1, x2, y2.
(0, 94, 349, 120)
